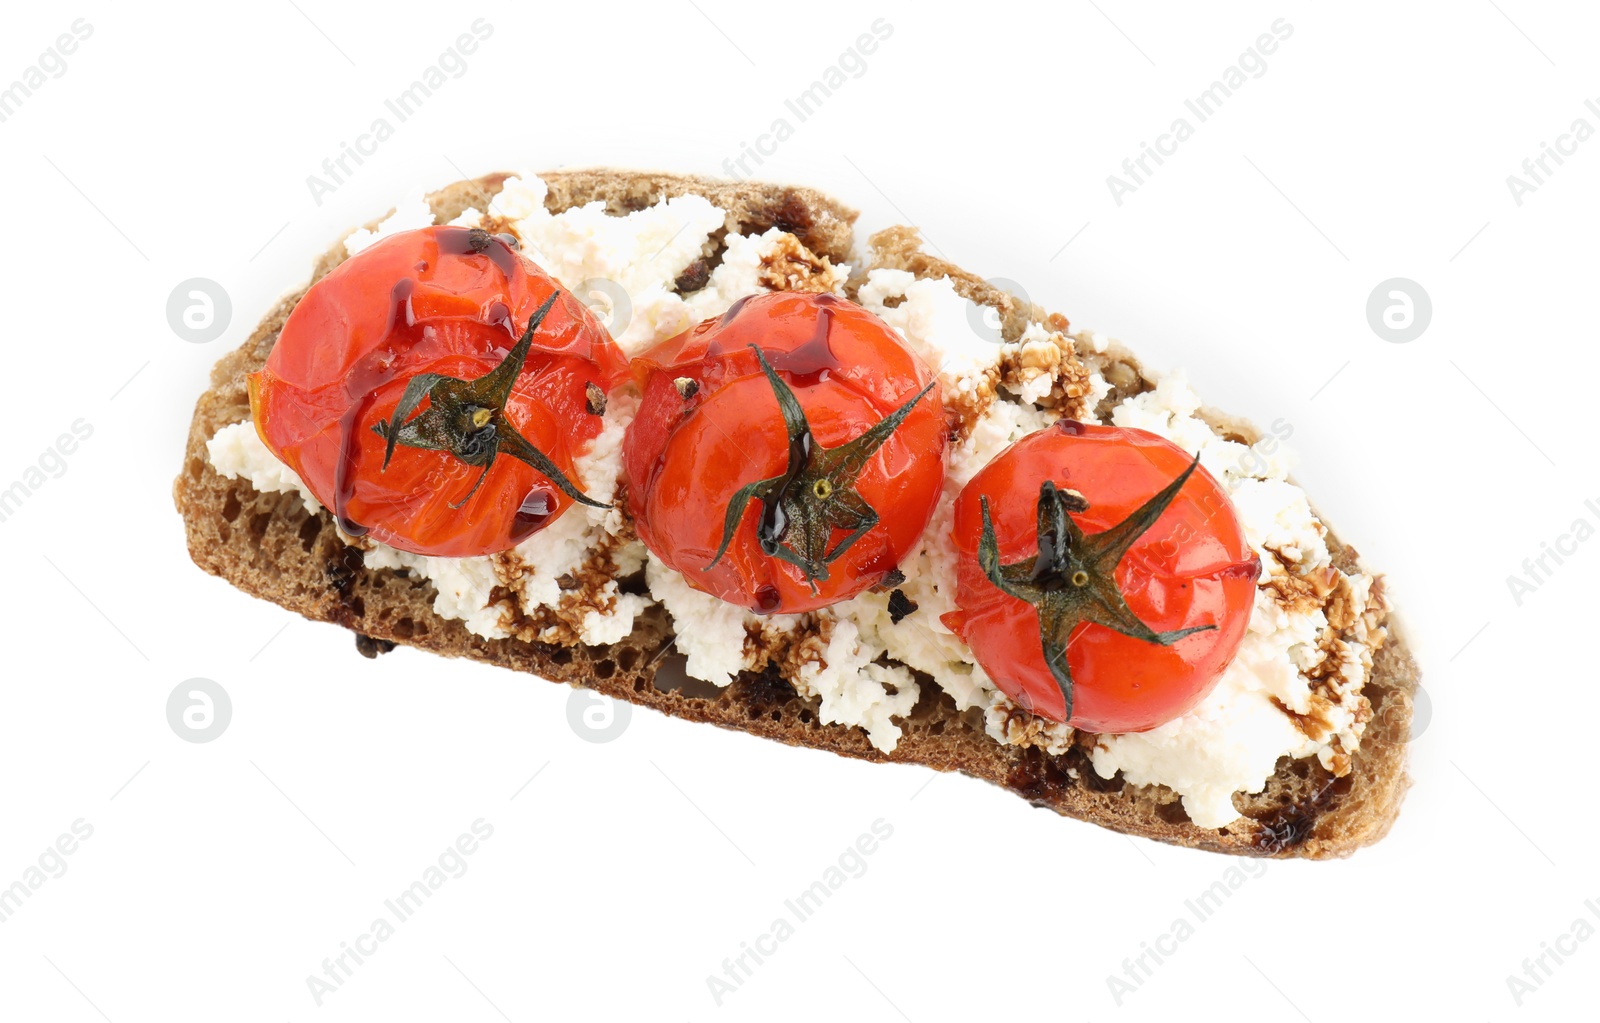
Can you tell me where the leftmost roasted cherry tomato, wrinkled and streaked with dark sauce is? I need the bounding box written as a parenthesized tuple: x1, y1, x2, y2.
(250, 227, 627, 557)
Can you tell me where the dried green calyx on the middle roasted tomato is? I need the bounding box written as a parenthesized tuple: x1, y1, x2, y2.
(710, 344, 934, 592)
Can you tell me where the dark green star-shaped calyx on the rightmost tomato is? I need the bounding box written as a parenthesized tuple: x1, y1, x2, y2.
(978, 455, 1216, 720)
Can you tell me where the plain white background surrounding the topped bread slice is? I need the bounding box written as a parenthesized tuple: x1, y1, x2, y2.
(0, 0, 1600, 1023)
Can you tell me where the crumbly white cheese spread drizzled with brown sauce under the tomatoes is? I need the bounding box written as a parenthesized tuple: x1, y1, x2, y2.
(206, 175, 1381, 828)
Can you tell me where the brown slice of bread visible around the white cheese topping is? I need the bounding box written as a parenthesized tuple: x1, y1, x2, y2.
(173, 170, 1418, 858)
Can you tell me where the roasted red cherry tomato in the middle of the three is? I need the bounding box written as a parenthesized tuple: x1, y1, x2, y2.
(622, 293, 946, 615)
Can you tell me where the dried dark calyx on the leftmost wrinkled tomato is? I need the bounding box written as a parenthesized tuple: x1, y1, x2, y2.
(373, 291, 610, 509)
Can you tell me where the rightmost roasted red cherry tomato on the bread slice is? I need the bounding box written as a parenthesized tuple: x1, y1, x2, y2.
(942, 419, 1261, 732)
